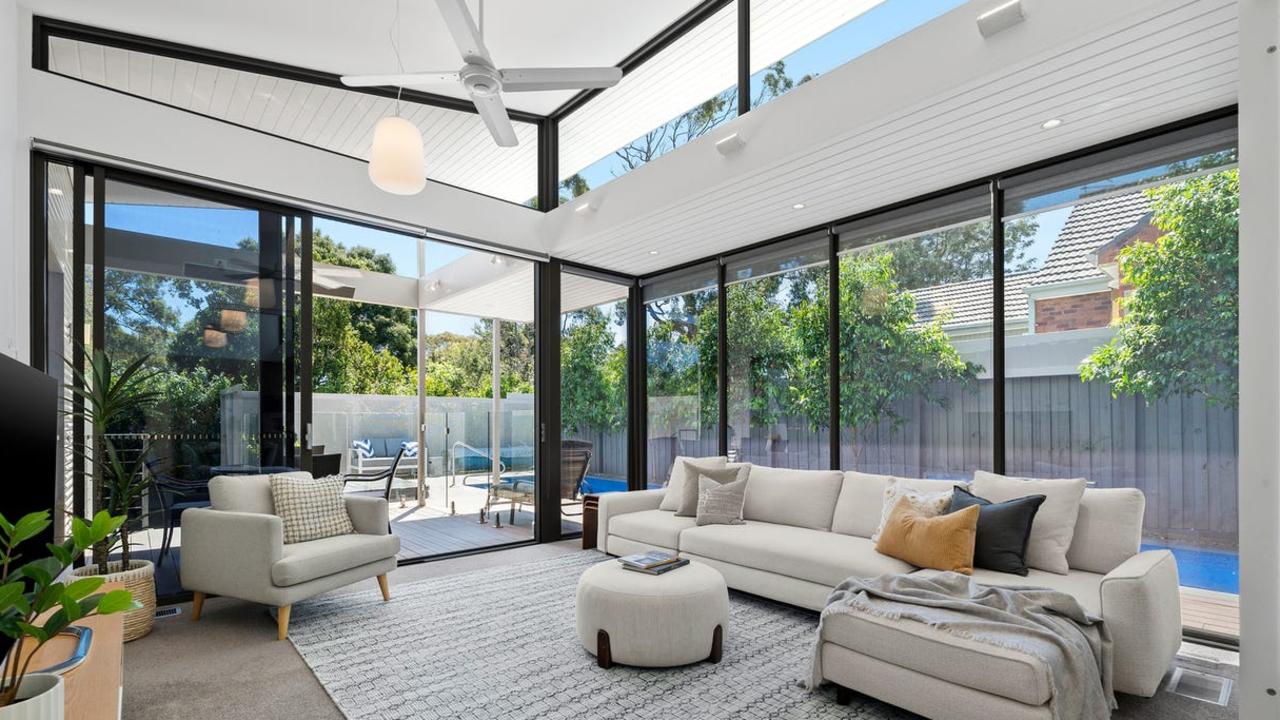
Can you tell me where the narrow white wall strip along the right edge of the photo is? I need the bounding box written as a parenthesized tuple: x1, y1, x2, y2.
(1239, 0, 1280, 720)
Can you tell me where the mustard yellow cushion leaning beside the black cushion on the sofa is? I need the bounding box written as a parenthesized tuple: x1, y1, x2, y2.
(876, 497, 978, 575)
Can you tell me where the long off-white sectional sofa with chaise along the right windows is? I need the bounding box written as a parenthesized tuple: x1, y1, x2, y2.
(596, 466, 1181, 707)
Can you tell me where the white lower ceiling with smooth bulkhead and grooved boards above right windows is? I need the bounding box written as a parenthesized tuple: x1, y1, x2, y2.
(544, 0, 1238, 274)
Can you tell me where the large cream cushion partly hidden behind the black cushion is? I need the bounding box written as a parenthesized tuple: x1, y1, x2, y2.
(973, 470, 1087, 575)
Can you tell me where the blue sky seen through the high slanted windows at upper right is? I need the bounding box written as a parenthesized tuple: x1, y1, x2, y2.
(570, 0, 965, 188)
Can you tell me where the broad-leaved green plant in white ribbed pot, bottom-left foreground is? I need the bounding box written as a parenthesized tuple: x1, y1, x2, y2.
(0, 511, 137, 720)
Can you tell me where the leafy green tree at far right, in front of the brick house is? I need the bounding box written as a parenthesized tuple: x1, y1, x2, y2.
(1080, 169, 1240, 407)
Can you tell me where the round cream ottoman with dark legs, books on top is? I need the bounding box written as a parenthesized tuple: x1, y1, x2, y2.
(577, 560, 728, 667)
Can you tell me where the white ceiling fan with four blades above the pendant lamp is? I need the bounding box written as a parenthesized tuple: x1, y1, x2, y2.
(342, 0, 622, 147)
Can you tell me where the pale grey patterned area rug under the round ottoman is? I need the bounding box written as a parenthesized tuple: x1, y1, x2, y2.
(289, 551, 914, 720)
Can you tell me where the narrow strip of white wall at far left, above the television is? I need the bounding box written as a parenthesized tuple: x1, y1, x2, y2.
(0, 0, 18, 359)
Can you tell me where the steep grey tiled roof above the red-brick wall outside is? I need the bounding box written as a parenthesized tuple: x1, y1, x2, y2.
(1030, 191, 1151, 287)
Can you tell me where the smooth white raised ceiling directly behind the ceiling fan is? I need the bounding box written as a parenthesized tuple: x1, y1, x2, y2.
(24, 0, 698, 114)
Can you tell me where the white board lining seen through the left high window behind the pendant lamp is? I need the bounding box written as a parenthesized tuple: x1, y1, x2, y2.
(49, 37, 538, 202)
